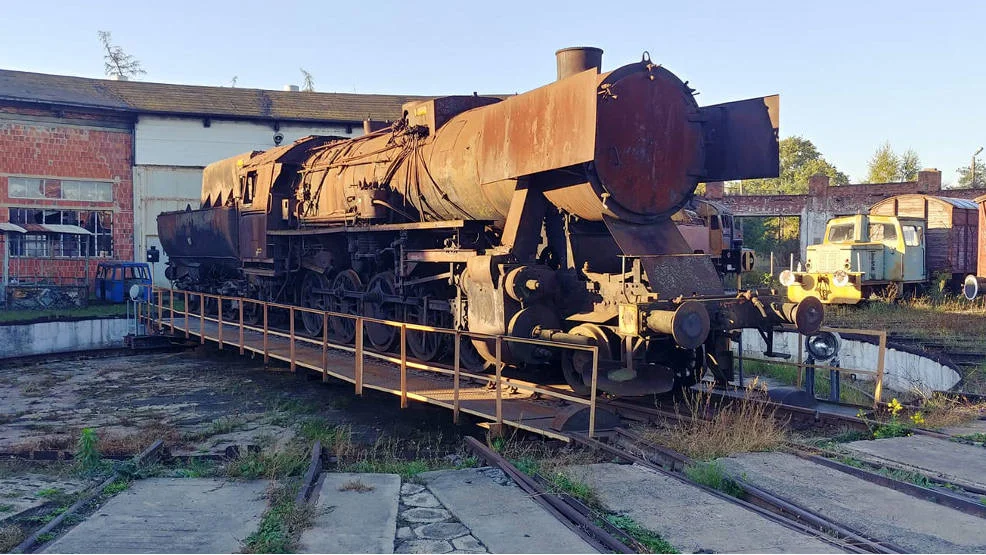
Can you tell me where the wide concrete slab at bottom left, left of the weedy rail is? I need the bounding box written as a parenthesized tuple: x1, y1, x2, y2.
(44, 478, 268, 553)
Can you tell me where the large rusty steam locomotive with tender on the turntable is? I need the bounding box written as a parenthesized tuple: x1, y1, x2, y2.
(158, 48, 822, 395)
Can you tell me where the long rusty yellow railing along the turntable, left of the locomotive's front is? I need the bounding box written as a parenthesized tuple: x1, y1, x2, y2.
(146, 287, 599, 437)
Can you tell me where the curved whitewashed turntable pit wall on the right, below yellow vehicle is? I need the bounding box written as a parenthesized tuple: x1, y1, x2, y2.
(733, 329, 961, 393)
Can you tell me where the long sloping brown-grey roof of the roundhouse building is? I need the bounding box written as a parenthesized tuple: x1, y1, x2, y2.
(0, 69, 429, 122)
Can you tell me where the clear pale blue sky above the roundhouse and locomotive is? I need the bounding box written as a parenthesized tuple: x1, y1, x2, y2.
(0, 0, 986, 187)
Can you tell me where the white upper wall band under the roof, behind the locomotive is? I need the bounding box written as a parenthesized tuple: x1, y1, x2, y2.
(134, 116, 363, 167)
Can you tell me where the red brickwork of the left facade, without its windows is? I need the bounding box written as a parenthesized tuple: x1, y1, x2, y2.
(0, 106, 134, 281)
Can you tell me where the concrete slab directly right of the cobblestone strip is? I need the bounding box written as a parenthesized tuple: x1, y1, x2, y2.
(413, 468, 596, 553)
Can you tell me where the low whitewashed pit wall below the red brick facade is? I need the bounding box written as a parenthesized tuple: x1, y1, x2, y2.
(0, 318, 133, 360)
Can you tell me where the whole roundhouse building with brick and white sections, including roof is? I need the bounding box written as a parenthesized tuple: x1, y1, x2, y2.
(0, 70, 421, 284)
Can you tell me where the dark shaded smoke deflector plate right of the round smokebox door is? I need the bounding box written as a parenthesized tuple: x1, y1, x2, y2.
(701, 95, 780, 181)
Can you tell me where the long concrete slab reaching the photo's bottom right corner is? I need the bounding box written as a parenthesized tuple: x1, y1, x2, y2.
(722, 453, 986, 553)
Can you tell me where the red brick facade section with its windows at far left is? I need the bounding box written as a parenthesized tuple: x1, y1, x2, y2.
(0, 103, 134, 283)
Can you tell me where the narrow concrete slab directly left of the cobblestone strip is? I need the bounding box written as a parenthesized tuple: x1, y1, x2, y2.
(298, 472, 401, 553)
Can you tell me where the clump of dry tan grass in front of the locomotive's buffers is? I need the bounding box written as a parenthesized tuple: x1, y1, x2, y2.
(640, 380, 787, 460)
